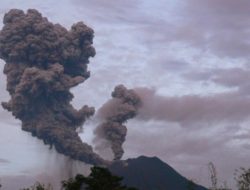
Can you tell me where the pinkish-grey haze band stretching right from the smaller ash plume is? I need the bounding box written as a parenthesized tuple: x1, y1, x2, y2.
(136, 88, 250, 126)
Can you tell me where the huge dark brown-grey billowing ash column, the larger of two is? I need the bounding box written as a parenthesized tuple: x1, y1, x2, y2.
(0, 9, 104, 164)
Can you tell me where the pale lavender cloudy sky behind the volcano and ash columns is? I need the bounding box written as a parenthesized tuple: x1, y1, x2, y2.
(0, 0, 250, 189)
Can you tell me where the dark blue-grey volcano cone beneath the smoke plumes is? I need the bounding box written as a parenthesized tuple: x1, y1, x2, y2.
(109, 156, 207, 190)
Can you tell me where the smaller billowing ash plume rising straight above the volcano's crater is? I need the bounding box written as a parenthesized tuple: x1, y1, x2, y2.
(95, 85, 141, 160)
